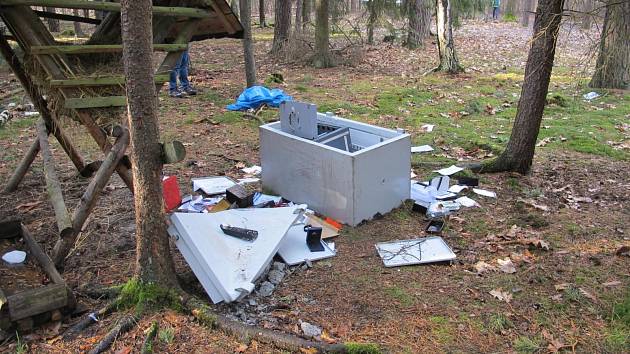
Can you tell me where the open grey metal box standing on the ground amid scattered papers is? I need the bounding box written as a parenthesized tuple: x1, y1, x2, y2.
(260, 113, 411, 226)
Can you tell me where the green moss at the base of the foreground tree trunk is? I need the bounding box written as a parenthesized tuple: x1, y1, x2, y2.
(116, 278, 183, 314)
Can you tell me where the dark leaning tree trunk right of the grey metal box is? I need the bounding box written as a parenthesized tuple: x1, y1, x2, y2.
(482, 0, 564, 174)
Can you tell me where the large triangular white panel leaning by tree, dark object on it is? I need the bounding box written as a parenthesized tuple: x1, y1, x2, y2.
(169, 206, 303, 303)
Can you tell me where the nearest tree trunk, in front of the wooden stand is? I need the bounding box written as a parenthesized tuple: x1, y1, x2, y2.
(121, 0, 178, 287)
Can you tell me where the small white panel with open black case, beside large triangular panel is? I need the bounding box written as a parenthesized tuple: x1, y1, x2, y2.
(278, 225, 337, 266)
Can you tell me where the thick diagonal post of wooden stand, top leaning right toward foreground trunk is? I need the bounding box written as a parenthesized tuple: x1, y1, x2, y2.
(53, 129, 129, 268)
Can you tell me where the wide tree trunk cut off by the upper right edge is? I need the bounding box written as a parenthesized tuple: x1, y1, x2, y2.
(589, 0, 630, 89)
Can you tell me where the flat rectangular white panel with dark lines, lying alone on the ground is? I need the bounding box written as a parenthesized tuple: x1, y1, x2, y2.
(376, 236, 456, 267)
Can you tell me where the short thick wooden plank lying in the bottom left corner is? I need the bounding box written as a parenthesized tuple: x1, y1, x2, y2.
(7, 284, 68, 321)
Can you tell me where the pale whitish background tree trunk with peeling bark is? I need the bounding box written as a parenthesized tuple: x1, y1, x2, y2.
(435, 0, 463, 74)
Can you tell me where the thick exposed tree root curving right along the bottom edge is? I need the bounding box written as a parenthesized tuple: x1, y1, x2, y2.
(186, 297, 348, 353)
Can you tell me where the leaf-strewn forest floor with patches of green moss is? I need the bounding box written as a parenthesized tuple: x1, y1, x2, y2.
(0, 22, 630, 353)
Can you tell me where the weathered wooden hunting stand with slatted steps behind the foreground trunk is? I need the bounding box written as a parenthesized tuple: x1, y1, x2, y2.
(0, 0, 243, 268)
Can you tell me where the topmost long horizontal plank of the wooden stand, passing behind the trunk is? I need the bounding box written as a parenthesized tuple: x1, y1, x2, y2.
(0, 0, 212, 18)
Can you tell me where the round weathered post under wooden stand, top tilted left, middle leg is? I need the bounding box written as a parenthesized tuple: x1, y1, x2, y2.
(37, 120, 73, 238)
